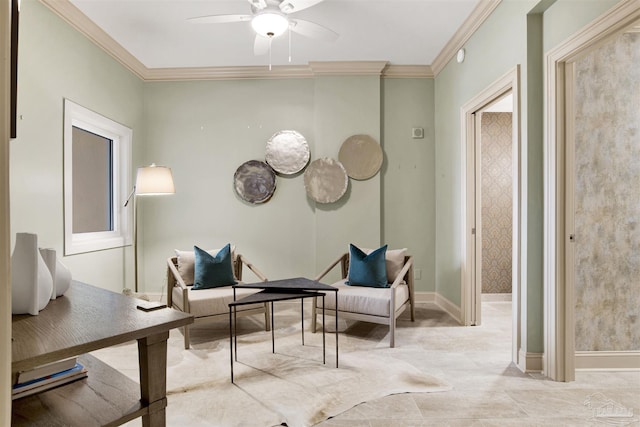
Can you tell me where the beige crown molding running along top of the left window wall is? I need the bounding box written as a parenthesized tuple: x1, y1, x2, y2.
(40, 0, 148, 79)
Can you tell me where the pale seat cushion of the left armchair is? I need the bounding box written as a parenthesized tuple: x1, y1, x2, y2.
(172, 286, 264, 317)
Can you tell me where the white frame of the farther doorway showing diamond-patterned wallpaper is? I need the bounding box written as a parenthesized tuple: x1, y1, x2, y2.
(460, 65, 522, 363)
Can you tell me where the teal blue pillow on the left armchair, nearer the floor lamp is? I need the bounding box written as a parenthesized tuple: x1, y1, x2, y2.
(193, 243, 237, 290)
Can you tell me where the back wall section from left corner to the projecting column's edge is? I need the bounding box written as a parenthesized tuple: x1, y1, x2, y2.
(138, 79, 323, 292)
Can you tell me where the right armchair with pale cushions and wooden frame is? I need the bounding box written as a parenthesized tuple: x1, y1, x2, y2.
(311, 245, 415, 347)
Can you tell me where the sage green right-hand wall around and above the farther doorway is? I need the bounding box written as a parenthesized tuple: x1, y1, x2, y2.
(435, 0, 542, 305)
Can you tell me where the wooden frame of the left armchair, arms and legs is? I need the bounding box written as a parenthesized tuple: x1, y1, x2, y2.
(167, 254, 271, 349)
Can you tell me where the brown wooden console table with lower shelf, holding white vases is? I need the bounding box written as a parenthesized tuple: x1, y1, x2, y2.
(11, 281, 193, 427)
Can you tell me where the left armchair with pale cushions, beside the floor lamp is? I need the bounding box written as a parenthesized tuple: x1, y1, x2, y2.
(167, 248, 271, 349)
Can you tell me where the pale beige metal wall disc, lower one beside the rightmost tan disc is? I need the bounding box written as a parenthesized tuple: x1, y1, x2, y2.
(304, 157, 349, 203)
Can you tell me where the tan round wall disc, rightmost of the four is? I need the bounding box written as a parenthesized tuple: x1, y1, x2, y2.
(338, 135, 382, 180)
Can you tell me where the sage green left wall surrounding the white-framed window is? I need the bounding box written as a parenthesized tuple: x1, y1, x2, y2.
(10, 0, 145, 291)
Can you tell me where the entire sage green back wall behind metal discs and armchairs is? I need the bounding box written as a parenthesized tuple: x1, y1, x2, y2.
(138, 76, 435, 292)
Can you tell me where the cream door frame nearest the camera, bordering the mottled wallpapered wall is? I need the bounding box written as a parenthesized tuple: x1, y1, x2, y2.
(543, 0, 640, 381)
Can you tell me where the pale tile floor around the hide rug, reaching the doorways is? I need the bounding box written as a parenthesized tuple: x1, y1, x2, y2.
(106, 302, 640, 427)
